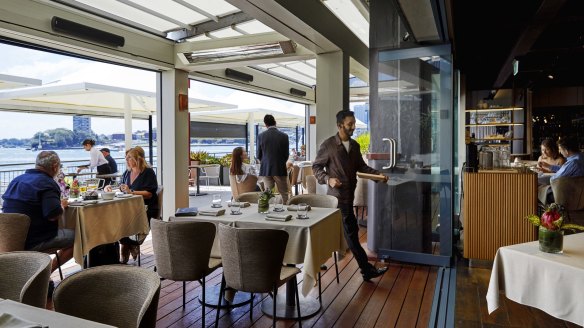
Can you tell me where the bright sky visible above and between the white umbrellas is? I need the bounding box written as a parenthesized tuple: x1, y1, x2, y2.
(0, 43, 304, 139)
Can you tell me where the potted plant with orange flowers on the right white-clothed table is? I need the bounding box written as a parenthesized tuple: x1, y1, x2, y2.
(526, 203, 584, 253)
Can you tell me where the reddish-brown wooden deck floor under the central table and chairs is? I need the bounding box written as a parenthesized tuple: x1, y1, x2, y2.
(52, 229, 437, 328)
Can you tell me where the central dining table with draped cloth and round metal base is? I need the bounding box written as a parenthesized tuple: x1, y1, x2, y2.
(170, 204, 348, 318)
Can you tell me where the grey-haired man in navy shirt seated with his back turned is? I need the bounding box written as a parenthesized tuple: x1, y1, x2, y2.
(2, 151, 75, 272)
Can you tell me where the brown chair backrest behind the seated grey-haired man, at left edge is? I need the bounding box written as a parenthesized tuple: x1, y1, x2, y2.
(0, 213, 30, 253)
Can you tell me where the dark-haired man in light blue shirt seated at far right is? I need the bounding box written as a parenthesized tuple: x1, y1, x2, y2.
(542, 137, 584, 181)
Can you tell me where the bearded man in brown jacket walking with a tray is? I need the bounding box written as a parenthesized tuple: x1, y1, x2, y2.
(312, 110, 388, 281)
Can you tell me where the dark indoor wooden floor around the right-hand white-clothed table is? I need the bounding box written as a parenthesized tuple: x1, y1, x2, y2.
(455, 261, 580, 328)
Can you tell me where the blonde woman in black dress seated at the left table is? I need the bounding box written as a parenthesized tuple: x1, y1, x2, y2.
(120, 148, 160, 263)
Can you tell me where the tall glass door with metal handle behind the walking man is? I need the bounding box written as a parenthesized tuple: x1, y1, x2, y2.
(368, 45, 456, 266)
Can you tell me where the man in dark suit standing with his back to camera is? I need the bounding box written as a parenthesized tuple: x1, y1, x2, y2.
(257, 114, 289, 204)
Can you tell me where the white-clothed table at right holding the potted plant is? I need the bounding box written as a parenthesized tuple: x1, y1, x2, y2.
(486, 233, 584, 325)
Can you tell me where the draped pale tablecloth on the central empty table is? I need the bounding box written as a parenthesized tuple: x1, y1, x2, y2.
(171, 204, 347, 296)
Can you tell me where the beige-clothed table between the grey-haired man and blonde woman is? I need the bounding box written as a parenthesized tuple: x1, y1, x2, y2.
(61, 194, 150, 265)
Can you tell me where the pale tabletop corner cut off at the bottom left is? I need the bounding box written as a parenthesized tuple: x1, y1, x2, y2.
(0, 300, 113, 328)
